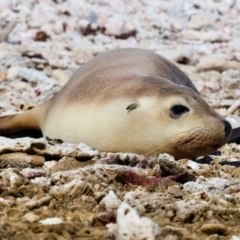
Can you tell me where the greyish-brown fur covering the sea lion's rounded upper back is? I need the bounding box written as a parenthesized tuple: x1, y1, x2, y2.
(54, 49, 198, 103)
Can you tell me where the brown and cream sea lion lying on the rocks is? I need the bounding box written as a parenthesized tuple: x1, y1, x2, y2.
(0, 49, 232, 159)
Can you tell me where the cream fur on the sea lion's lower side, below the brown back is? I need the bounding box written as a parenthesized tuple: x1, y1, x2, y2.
(41, 97, 164, 154)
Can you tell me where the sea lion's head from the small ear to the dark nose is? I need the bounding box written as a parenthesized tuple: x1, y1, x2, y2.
(124, 77, 232, 159)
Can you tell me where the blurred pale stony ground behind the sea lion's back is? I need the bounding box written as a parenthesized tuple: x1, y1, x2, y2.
(0, 0, 240, 125)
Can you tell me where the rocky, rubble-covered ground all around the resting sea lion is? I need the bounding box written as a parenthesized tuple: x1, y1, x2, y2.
(0, 0, 240, 240)
